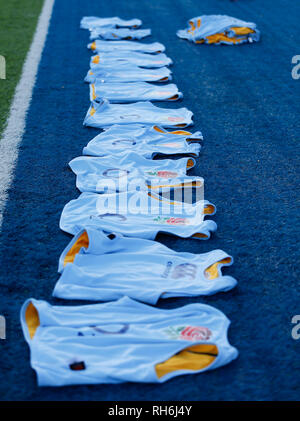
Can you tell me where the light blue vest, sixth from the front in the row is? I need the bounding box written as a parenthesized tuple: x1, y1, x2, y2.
(83, 99, 193, 129)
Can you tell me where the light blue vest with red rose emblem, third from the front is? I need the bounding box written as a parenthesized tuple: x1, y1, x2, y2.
(60, 191, 217, 240)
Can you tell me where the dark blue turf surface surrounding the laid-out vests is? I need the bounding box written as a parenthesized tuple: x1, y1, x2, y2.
(0, 0, 300, 400)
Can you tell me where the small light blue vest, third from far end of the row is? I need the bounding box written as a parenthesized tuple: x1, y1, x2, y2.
(88, 39, 165, 53)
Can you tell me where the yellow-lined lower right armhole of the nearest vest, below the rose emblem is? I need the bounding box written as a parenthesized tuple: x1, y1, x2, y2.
(155, 344, 219, 379)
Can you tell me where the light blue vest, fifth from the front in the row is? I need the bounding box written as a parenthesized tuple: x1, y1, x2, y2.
(83, 124, 203, 159)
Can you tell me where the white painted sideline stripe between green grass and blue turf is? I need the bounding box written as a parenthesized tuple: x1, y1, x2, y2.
(0, 0, 55, 230)
